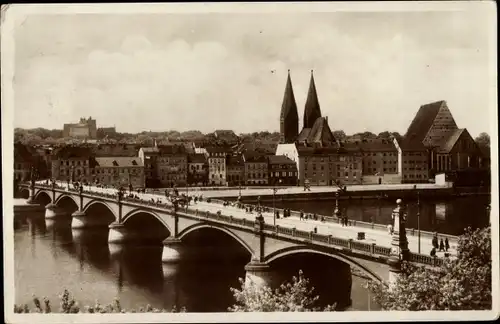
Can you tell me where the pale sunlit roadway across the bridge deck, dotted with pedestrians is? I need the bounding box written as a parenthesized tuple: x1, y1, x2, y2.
(35, 181, 457, 257)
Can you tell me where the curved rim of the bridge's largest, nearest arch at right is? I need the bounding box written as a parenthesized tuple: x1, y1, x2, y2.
(264, 245, 384, 282)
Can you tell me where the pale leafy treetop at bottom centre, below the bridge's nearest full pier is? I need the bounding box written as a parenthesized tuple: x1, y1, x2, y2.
(228, 271, 334, 312)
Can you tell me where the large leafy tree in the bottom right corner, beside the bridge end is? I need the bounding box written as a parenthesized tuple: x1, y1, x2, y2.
(368, 227, 492, 311)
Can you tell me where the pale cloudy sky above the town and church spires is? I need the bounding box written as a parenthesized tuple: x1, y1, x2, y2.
(8, 2, 496, 137)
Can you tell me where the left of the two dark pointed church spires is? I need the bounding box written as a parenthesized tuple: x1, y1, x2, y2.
(280, 70, 299, 144)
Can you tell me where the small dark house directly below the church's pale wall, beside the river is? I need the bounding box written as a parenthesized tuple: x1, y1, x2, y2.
(267, 155, 299, 186)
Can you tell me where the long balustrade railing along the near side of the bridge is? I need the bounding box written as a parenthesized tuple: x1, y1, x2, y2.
(33, 185, 452, 266)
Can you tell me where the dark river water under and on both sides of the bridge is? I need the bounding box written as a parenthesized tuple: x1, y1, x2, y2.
(14, 197, 489, 312)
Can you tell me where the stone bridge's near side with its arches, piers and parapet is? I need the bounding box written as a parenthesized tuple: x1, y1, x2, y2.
(20, 184, 443, 298)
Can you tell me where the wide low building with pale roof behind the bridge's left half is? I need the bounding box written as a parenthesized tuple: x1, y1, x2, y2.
(92, 156, 145, 189)
